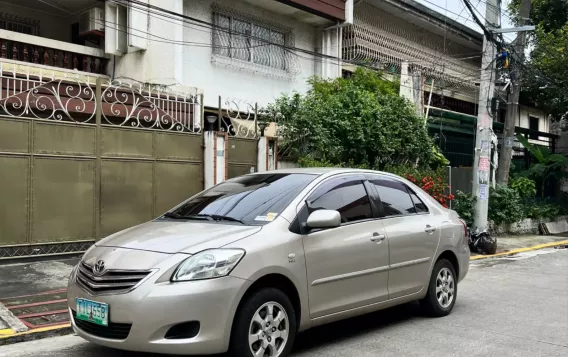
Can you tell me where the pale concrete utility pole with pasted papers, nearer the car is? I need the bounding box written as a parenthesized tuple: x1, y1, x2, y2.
(472, 0, 501, 232)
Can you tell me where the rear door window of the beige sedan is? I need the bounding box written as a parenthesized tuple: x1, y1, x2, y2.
(369, 177, 416, 217)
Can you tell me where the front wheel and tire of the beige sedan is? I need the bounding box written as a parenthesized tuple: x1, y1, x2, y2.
(229, 288, 297, 357)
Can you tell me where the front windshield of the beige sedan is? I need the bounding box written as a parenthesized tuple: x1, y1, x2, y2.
(165, 173, 317, 225)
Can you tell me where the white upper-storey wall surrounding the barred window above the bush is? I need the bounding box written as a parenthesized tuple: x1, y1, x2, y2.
(183, 0, 318, 107)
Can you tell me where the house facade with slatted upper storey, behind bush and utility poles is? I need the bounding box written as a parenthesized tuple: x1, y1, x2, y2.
(342, 0, 554, 167)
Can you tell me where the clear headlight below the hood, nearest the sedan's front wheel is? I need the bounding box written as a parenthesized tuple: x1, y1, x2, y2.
(172, 249, 245, 281)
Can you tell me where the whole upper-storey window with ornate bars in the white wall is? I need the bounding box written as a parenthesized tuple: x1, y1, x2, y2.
(213, 13, 288, 71)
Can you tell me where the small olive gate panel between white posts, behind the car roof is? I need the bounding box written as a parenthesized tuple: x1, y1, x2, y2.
(228, 137, 258, 178)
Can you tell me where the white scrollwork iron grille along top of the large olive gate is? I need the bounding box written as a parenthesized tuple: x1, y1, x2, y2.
(0, 63, 203, 133)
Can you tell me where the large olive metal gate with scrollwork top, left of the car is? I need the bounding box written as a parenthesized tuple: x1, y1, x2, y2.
(0, 74, 203, 259)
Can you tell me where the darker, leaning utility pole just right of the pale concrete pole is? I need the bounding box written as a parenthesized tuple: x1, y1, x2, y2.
(497, 0, 531, 185)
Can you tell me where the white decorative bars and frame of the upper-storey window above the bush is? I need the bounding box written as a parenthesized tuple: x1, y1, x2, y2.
(211, 8, 293, 73)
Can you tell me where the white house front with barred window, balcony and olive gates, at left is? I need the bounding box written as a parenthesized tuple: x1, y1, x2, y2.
(0, 0, 353, 259)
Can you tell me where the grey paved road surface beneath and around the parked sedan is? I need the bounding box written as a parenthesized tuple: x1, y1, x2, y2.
(0, 249, 568, 357)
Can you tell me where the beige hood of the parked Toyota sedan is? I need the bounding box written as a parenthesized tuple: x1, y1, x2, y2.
(95, 220, 262, 254)
